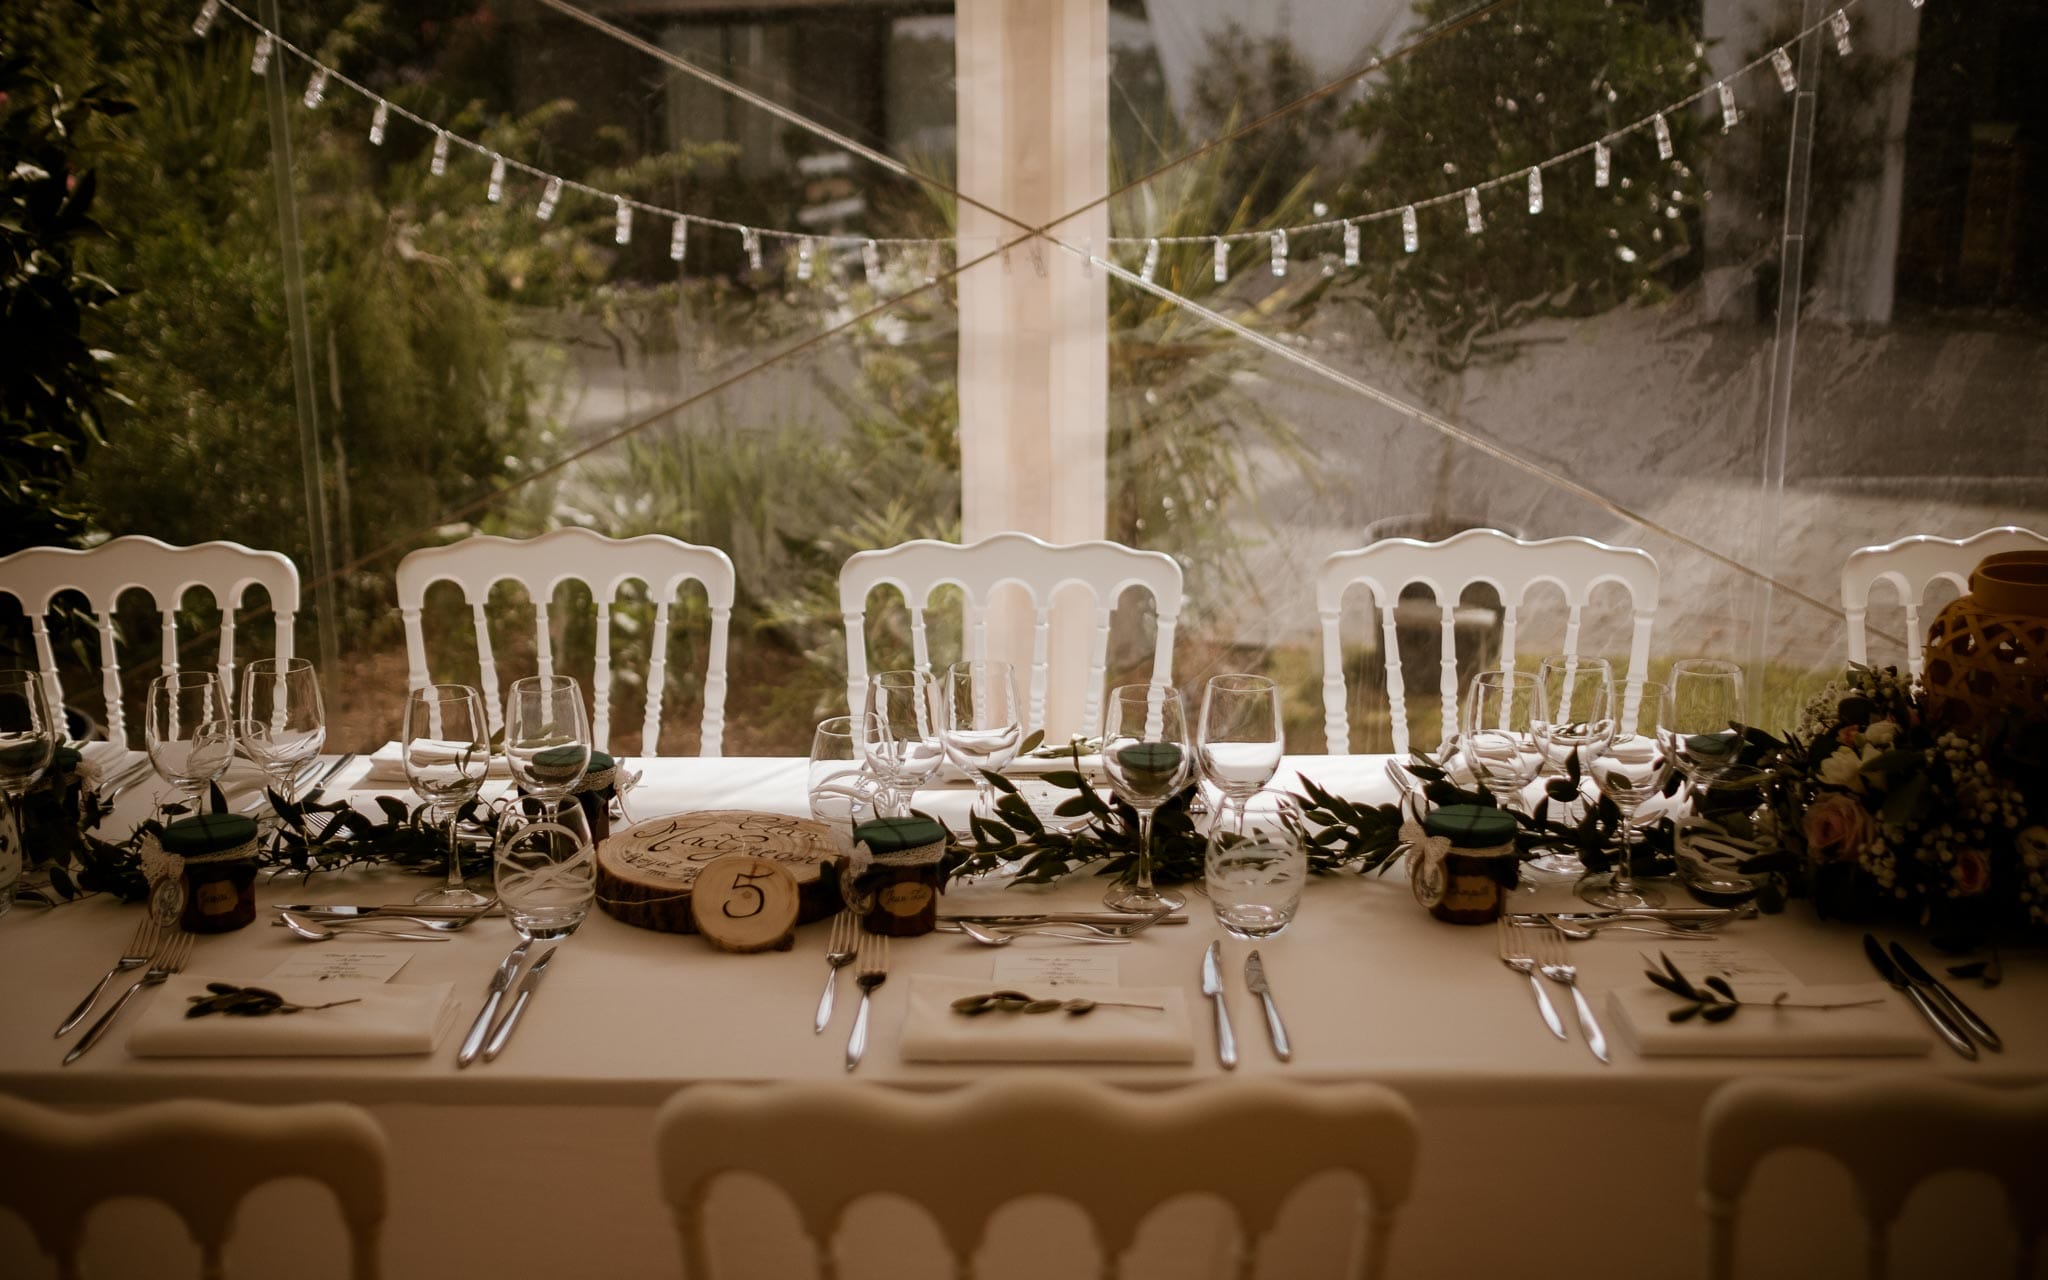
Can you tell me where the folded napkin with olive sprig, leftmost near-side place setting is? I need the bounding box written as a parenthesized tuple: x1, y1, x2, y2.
(129, 973, 459, 1057)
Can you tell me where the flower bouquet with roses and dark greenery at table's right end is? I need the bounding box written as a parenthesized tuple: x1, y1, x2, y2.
(1753, 666, 2048, 934)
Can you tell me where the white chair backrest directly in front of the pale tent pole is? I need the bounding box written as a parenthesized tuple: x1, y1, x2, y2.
(840, 532, 1182, 737)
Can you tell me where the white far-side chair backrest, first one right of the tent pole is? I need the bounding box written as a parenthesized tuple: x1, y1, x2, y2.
(1315, 528, 1659, 756)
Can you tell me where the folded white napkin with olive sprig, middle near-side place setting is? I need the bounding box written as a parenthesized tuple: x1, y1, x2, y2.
(903, 973, 1194, 1063)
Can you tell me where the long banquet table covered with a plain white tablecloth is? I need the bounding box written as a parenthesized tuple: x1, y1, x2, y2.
(0, 756, 2048, 1276)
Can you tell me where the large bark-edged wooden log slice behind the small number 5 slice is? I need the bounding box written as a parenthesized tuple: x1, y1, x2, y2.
(598, 809, 840, 934)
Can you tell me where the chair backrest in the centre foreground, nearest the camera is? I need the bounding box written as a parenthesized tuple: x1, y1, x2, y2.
(655, 1073, 1419, 1280)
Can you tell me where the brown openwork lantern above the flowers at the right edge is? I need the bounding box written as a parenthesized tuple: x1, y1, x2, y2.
(1921, 551, 2048, 729)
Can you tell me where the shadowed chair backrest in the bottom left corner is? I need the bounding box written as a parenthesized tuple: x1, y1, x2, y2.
(0, 1098, 385, 1280)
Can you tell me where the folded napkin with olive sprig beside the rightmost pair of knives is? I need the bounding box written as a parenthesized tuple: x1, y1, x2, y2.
(1608, 983, 1933, 1057)
